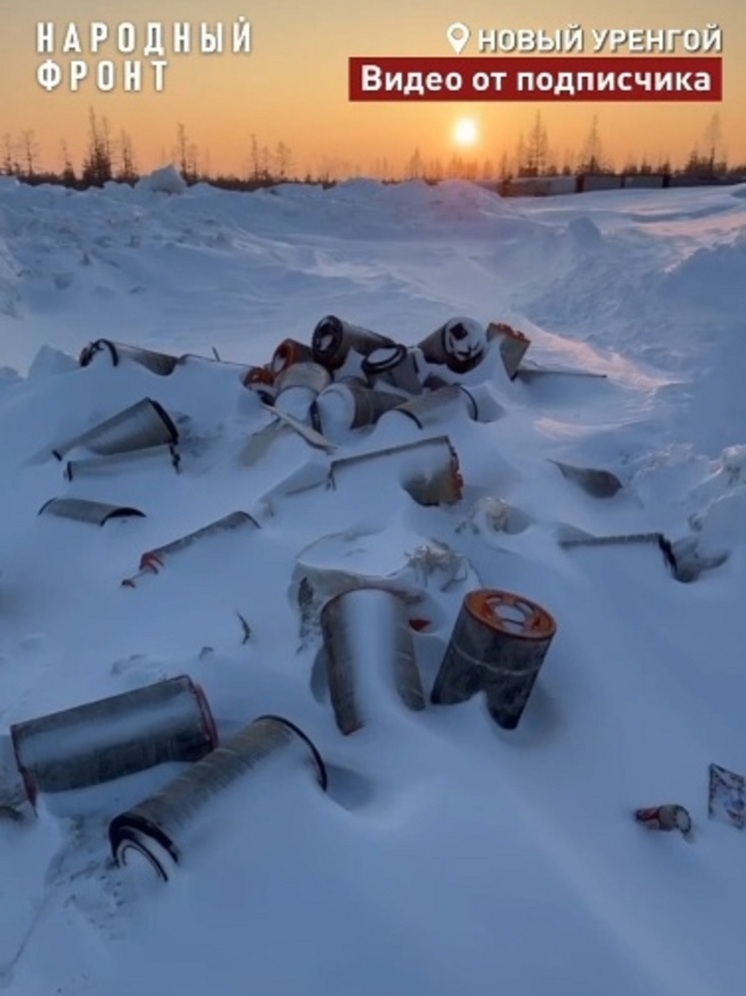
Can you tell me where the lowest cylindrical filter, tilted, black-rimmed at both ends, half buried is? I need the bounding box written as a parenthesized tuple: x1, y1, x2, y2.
(109, 716, 327, 881)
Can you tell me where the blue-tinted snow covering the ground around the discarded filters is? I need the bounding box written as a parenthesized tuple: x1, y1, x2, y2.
(0, 174, 746, 996)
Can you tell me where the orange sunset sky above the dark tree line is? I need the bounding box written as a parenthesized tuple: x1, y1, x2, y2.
(0, 0, 746, 175)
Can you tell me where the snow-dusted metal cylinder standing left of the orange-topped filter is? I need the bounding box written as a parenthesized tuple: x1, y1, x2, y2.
(321, 588, 425, 735)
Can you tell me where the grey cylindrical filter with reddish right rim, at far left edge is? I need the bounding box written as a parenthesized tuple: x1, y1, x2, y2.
(10, 675, 217, 802)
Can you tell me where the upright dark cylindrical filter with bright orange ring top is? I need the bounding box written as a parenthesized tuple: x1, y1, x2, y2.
(431, 589, 556, 730)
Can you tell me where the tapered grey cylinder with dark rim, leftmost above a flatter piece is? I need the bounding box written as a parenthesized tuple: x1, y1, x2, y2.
(52, 398, 179, 460)
